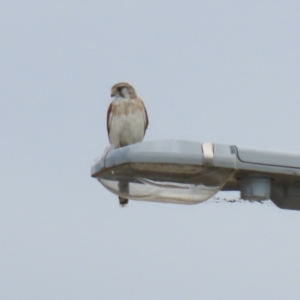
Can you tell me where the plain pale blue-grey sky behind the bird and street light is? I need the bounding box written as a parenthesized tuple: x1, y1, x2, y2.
(0, 0, 300, 300)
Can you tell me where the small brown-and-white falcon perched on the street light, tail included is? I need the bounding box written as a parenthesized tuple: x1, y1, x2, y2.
(106, 82, 149, 207)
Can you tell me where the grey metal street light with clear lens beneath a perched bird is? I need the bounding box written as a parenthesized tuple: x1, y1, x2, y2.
(91, 140, 300, 210)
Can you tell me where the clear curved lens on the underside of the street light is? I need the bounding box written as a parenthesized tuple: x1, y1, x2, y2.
(97, 163, 231, 204)
